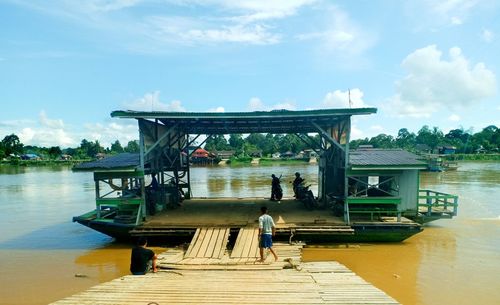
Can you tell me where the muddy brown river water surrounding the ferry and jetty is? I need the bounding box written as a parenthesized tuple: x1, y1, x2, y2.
(0, 162, 500, 305)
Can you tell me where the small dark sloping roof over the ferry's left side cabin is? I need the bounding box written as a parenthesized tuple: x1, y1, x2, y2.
(73, 153, 140, 171)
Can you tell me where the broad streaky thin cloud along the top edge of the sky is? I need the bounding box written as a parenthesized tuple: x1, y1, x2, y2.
(17, 0, 316, 48)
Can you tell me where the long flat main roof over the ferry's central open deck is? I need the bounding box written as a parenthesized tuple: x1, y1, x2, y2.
(111, 108, 377, 134)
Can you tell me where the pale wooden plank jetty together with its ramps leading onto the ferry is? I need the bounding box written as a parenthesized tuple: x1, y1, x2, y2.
(52, 227, 398, 305)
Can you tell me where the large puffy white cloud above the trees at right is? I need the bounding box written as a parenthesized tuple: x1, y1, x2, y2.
(382, 45, 496, 117)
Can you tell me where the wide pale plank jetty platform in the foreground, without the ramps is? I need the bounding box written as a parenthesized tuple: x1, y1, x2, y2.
(52, 262, 398, 305)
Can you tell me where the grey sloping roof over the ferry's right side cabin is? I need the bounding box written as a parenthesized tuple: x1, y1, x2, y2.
(349, 148, 427, 168)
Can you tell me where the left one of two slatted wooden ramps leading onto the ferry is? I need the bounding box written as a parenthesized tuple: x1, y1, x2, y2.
(184, 228, 229, 259)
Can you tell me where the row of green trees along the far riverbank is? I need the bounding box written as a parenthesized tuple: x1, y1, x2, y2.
(0, 125, 500, 159)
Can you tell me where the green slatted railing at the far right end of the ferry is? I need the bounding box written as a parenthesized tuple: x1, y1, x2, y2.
(418, 190, 458, 216)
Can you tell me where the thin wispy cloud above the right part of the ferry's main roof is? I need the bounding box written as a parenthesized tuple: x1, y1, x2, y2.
(298, 7, 377, 57)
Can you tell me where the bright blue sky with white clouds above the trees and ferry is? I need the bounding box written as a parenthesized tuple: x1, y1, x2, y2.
(0, 0, 500, 147)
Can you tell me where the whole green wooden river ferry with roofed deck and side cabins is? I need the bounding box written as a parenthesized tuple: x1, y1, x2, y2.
(73, 108, 458, 242)
